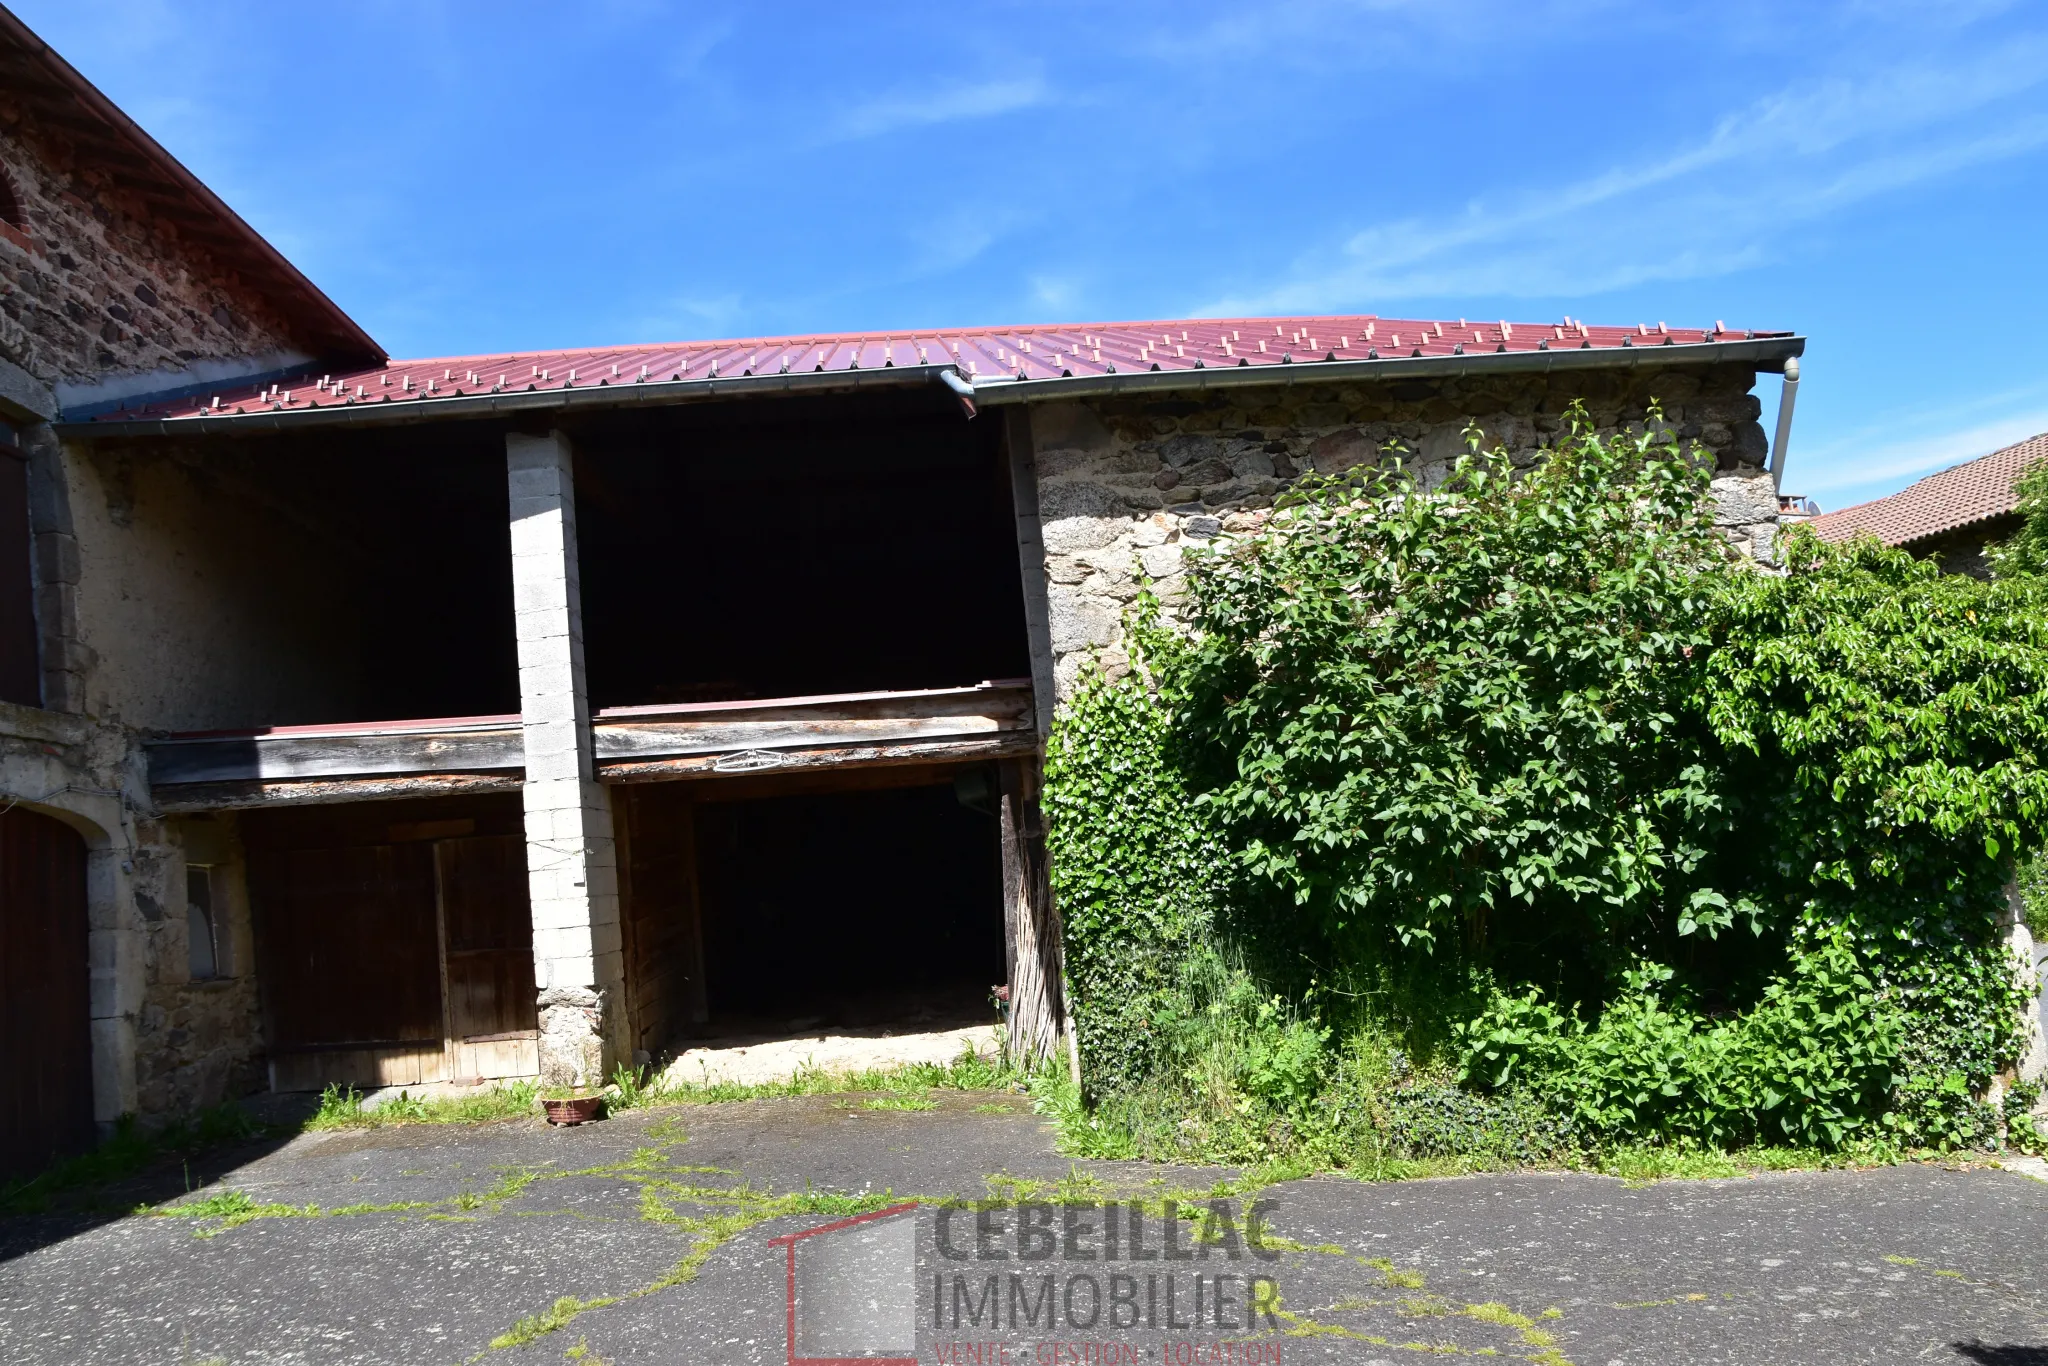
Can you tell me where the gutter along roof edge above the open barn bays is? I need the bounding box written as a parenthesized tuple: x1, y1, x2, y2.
(57, 365, 966, 440)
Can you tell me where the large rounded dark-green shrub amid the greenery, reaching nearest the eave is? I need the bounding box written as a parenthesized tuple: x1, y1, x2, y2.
(1147, 410, 1729, 970)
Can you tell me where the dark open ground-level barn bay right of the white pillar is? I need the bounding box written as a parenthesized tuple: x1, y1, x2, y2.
(614, 764, 1006, 1059)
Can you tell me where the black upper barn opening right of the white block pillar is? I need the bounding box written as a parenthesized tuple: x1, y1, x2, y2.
(573, 387, 1030, 709)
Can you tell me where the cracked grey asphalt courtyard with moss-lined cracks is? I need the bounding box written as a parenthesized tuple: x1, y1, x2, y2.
(0, 1094, 2048, 1366)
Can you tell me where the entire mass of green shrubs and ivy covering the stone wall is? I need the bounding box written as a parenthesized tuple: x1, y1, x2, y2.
(1044, 410, 2048, 1165)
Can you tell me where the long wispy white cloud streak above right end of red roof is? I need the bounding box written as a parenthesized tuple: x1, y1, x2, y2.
(1198, 39, 2048, 315)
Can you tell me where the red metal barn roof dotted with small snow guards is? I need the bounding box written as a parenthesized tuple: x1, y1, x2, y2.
(98, 313, 1792, 422)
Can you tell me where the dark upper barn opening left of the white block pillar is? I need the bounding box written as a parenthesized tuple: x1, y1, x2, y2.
(86, 422, 520, 731)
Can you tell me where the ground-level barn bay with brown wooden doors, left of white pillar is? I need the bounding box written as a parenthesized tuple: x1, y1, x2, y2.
(242, 793, 539, 1092)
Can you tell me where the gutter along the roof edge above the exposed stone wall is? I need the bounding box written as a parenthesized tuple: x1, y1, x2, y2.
(975, 336, 1806, 405)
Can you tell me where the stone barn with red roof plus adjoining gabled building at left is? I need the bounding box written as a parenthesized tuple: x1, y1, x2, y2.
(0, 10, 1802, 1167)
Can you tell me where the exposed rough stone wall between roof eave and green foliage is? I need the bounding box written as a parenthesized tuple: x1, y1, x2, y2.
(1032, 365, 1778, 698)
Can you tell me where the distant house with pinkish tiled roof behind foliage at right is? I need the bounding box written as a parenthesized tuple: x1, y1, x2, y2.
(1810, 432, 2048, 578)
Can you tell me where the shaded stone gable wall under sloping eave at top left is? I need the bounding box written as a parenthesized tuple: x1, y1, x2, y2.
(0, 109, 303, 389)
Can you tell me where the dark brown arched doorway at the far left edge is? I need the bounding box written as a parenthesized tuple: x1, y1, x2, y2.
(0, 807, 92, 1178)
